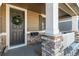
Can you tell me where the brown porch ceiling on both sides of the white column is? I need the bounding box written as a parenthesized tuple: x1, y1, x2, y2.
(10, 3, 79, 18)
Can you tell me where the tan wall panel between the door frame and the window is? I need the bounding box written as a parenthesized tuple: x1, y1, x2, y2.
(27, 10, 39, 31)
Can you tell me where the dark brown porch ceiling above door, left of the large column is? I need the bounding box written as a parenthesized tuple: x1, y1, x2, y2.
(10, 3, 45, 14)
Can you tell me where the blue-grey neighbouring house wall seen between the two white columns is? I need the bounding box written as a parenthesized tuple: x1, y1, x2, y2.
(59, 17, 72, 32)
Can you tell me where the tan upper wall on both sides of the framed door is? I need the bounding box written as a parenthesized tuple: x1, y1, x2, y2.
(0, 3, 40, 32)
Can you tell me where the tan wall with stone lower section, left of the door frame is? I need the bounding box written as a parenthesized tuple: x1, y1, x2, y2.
(0, 4, 6, 46)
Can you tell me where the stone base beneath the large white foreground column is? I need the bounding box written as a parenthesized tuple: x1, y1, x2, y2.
(41, 35, 64, 56)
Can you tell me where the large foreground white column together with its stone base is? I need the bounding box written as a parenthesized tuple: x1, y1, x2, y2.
(41, 3, 64, 56)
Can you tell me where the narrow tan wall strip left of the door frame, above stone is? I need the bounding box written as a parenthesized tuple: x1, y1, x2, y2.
(0, 4, 6, 32)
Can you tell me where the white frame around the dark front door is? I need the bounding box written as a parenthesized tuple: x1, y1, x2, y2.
(6, 4, 27, 50)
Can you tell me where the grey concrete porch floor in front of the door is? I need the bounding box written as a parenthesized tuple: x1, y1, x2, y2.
(3, 43, 41, 56)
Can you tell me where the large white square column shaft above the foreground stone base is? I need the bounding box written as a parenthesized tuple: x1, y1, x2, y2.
(46, 3, 59, 35)
